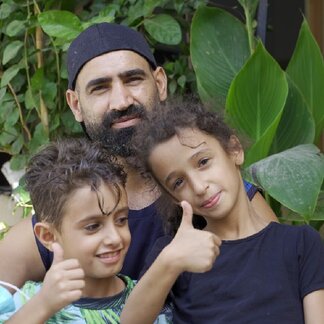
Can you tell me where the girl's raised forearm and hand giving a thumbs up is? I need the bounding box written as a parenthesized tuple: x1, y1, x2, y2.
(120, 202, 221, 324)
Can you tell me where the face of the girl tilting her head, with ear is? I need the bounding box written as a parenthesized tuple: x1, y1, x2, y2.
(149, 128, 246, 222)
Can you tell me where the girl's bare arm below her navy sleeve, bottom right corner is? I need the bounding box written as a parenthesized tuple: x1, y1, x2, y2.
(303, 289, 324, 324)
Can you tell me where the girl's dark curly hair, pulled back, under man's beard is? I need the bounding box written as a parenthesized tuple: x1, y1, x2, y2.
(131, 97, 235, 234)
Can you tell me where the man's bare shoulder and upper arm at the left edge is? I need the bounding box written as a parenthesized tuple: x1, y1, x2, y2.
(0, 217, 45, 292)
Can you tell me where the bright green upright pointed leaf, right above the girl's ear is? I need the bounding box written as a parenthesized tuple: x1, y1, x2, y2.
(226, 42, 288, 165)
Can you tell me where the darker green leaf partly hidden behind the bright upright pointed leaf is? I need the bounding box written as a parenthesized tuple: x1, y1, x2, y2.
(271, 76, 315, 153)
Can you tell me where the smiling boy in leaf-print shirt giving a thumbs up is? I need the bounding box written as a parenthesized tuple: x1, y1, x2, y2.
(0, 139, 172, 324)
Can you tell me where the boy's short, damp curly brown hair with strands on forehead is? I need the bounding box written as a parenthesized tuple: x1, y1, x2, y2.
(24, 138, 126, 230)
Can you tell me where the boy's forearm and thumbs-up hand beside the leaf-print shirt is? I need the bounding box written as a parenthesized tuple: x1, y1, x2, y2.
(6, 243, 84, 324)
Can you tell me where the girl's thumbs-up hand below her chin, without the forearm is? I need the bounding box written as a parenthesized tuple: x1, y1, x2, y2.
(165, 201, 221, 273)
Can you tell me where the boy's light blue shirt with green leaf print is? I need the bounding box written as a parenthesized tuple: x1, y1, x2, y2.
(0, 275, 172, 324)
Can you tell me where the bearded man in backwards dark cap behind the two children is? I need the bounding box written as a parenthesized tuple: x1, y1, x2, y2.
(0, 23, 276, 286)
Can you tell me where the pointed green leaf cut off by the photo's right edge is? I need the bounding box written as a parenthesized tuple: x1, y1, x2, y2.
(287, 20, 324, 141)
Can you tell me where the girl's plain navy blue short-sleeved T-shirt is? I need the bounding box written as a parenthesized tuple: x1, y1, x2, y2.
(145, 222, 324, 324)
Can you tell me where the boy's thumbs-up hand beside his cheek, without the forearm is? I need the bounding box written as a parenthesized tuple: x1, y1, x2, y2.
(39, 243, 85, 316)
